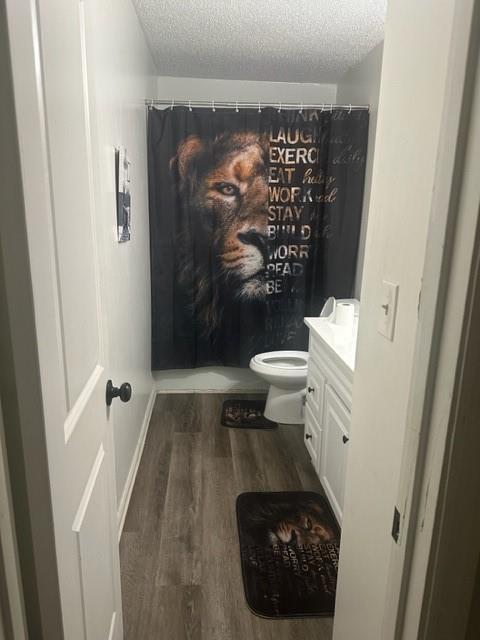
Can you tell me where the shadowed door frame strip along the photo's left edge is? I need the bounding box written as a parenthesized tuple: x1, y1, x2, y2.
(0, 2, 63, 640)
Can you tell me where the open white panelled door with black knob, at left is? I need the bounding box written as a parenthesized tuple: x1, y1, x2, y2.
(7, 0, 123, 640)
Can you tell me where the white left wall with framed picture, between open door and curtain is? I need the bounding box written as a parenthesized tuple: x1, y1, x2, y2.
(85, 0, 155, 507)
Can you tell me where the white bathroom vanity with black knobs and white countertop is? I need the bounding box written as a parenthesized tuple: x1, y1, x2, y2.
(304, 318, 358, 524)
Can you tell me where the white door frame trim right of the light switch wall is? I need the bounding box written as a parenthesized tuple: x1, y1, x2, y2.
(382, 0, 480, 640)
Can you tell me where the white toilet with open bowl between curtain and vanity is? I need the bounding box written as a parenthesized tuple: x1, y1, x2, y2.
(250, 351, 308, 424)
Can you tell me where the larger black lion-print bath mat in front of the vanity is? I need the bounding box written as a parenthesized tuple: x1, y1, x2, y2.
(237, 491, 340, 618)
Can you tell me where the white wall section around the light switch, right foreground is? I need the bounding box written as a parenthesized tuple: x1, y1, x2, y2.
(334, 0, 455, 640)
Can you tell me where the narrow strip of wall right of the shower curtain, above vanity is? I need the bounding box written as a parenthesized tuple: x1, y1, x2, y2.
(337, 42, 383, 299)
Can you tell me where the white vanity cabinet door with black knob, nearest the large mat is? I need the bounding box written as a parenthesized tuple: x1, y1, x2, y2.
(320, 384, 350, 523)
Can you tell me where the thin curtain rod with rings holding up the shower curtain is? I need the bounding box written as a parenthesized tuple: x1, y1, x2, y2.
(145, 98, 370, 111)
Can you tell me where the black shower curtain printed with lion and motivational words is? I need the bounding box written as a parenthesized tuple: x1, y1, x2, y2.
(148, 107, 368, 370)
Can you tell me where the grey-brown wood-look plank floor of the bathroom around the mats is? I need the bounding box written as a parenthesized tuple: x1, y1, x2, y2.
(120, 394, 332, 640)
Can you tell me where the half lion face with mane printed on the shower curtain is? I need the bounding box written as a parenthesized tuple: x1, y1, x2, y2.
(170, 131, 268, 336)
